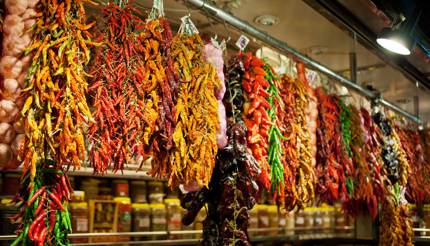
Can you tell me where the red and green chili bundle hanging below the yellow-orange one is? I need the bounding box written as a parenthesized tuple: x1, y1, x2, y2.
(11, 161, 72, 245)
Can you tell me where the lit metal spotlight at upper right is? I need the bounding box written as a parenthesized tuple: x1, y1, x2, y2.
(376, 11, 421, 55)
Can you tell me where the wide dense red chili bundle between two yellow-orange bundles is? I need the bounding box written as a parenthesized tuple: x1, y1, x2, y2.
(89, 3, 154, 173)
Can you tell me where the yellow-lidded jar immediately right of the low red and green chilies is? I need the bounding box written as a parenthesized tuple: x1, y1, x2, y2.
(70, 202, 89, 243)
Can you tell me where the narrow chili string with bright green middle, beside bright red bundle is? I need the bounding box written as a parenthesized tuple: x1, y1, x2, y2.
(263, 63, 285, 200)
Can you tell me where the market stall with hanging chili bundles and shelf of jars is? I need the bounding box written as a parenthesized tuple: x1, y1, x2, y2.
(0, 0, 430, 245)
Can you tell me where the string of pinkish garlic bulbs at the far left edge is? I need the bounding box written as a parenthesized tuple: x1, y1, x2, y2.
(0, 0, 38, 168)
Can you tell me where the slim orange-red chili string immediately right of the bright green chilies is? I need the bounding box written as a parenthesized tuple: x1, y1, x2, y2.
(278, 75, 299, 211)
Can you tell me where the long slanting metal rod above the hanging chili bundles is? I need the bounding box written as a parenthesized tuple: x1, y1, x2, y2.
(185, 0, 422, 124)
